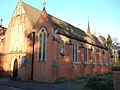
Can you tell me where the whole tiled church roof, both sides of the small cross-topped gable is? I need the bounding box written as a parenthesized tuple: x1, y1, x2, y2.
(23, 3, 107, 49)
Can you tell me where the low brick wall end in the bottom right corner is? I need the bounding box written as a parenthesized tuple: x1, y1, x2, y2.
(112, 67, 120, 90)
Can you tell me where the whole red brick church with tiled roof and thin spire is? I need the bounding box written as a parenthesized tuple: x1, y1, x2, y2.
(1, 0, 111, 82)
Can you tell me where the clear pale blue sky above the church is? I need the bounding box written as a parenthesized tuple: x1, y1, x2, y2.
(0, 0, 120, 41)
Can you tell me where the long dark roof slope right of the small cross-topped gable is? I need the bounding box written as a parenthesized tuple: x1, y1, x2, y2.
(48, 14, 107, 49)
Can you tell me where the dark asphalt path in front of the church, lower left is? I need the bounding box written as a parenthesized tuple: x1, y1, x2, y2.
(0, 79, 75, 90)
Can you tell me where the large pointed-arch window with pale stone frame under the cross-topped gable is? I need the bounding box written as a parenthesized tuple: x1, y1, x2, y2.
(38, 27, 47, 61)
